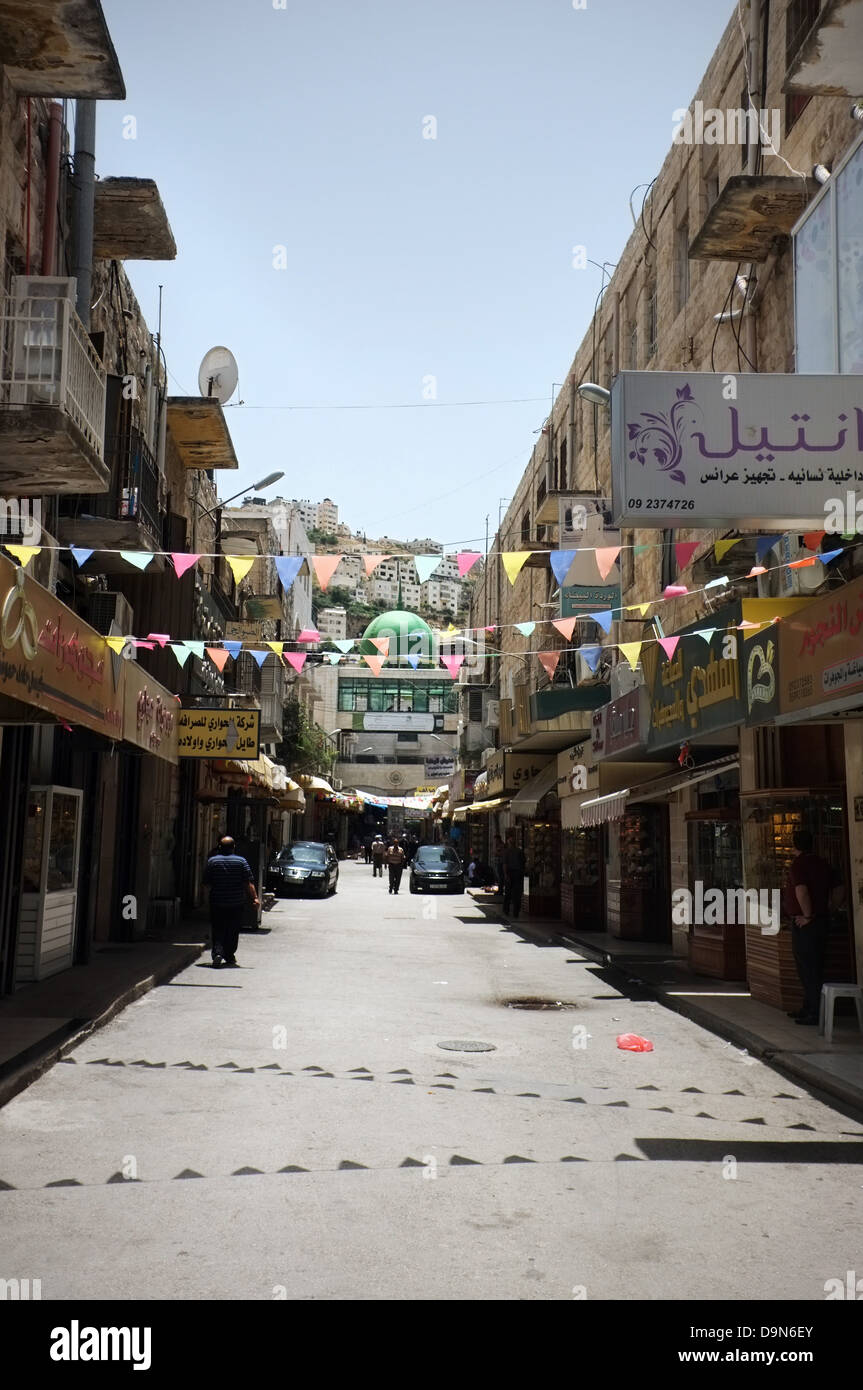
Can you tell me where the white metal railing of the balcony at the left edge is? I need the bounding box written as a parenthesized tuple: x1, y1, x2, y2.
(0, 281, 106, 460)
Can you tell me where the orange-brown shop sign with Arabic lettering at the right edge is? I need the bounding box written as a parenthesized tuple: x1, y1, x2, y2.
(780, 580, 863, 714)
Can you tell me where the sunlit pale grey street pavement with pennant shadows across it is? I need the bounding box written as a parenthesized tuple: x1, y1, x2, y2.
(0, 863, 863, 1301)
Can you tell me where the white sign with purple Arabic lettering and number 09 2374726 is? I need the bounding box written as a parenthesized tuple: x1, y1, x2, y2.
(611, 371, 863, 531)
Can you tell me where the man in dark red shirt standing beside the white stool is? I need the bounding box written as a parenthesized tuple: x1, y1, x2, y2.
(782, 830, 832, 1024)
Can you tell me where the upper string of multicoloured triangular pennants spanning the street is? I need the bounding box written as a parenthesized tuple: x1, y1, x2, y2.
(6, 531, 842, 592)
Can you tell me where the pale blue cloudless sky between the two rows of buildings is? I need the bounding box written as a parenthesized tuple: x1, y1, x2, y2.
(97, 0, 732, 545)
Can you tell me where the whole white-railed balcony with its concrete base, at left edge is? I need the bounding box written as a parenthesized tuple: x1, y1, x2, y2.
(0, 277, 108, 495)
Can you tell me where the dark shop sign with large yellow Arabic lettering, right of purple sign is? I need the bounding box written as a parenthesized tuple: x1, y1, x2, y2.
(642, 603, 745, 751)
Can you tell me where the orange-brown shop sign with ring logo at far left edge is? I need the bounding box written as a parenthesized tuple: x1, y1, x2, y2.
(0, 556, 126, 738)
